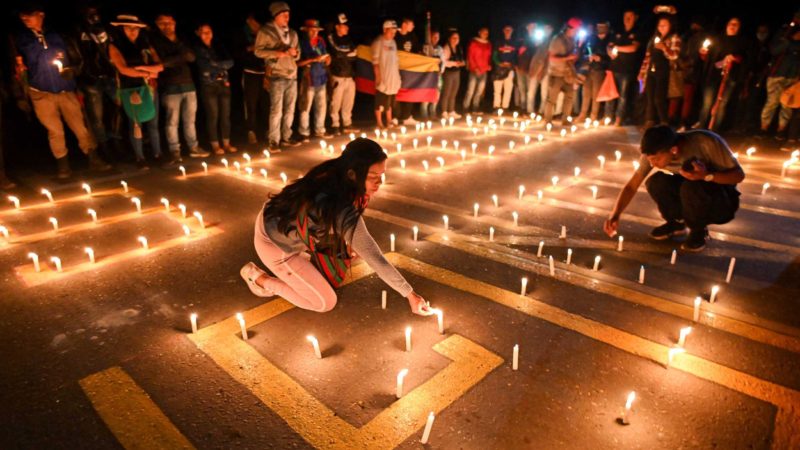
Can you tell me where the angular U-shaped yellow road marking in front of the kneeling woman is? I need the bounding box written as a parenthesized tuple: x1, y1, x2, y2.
(189, 258, 503, 449)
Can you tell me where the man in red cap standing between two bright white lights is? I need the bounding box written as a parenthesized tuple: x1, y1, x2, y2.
(544, 17, 582, 123)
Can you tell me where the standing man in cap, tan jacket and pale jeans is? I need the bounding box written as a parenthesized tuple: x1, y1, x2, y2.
(255, 2, 300, 152)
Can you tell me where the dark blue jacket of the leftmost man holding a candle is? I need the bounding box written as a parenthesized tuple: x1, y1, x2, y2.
(16, 30, 77, 93)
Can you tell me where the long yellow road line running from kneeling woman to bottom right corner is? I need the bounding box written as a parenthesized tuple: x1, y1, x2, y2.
(387, 253, 800, 449)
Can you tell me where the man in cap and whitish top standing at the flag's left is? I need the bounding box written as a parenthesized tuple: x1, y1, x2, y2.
(371, 20, 400, 128)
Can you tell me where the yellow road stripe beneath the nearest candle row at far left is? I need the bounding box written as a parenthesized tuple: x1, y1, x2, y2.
(14, 225, 223, 287)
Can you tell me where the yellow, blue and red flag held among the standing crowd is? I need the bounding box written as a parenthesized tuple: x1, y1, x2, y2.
(356, 45, 440, 103)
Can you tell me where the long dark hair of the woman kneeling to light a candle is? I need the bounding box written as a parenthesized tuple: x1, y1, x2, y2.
(264, 138, 386, 251)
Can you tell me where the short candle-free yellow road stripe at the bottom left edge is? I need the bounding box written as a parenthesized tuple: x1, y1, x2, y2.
(79, 367, 194, 450)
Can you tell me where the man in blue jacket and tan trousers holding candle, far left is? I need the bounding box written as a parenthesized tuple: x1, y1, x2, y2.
(14, 5, 111, 179)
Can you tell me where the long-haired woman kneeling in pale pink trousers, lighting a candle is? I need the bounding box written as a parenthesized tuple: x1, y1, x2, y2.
(241, 139, 431, 315)
